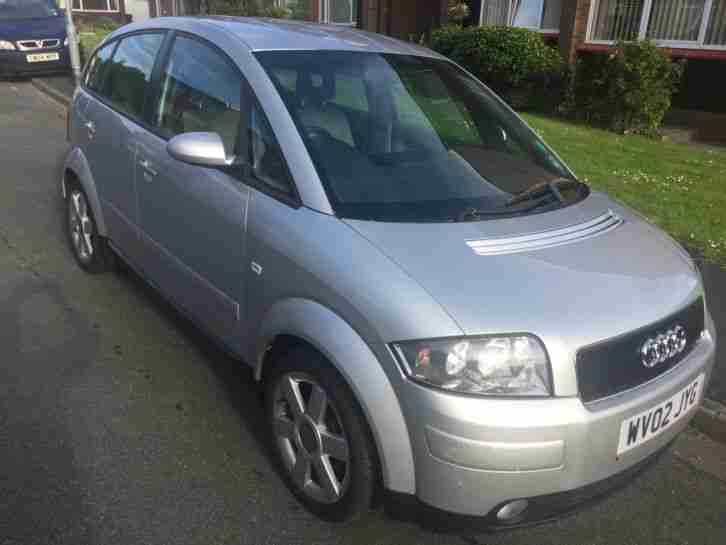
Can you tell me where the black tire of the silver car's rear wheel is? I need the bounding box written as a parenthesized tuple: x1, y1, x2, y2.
(64, 180, 115, 274)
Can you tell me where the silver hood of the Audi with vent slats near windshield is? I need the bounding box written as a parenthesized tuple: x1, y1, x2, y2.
(346, 192, 702, 392)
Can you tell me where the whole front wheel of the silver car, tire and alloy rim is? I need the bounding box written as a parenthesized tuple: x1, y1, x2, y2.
(266, 346, 378, 521)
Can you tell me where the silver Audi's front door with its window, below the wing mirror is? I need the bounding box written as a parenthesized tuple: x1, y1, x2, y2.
(136, 36, 249, 350)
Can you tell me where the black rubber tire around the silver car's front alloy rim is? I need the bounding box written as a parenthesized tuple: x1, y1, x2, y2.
(265, 345, 379, 522)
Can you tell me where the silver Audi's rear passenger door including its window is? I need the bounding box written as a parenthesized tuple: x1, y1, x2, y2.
(84, 32, 165, 262)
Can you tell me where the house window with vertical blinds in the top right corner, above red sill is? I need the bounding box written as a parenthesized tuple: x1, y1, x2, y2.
(588, 0, 726, 48)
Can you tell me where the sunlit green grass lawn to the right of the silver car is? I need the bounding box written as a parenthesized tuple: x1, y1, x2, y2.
(524, 114, 726, 264)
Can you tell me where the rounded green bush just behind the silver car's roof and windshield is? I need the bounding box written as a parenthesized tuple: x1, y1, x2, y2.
(430, 25, 566, 109)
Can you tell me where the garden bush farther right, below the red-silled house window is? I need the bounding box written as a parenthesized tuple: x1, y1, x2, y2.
(567, 41, 684, 135)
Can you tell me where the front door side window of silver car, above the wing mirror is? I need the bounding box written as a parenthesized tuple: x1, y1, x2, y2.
(155, 37, 242, 156)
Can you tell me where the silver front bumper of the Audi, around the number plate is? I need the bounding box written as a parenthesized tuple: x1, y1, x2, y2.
(400, 306, 716, 524)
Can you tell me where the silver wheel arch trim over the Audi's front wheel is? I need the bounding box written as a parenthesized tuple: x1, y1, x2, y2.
(254, 298, 416, 494)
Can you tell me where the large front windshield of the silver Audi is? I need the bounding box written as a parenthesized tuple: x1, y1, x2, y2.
(256, 51, 588, 222)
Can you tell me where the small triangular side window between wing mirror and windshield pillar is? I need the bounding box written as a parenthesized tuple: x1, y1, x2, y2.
(248, 101, 293, 195)
